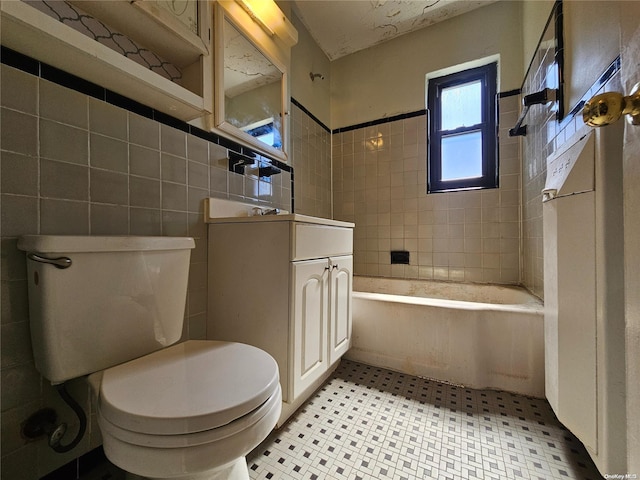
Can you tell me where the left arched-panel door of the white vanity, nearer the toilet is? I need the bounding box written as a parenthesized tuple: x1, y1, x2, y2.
(291, 258, 330, 398)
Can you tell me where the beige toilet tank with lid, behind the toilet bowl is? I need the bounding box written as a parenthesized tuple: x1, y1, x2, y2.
(18, 235, 195, 383)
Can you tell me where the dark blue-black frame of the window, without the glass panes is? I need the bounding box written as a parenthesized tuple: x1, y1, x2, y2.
(427, 62, 498, 193)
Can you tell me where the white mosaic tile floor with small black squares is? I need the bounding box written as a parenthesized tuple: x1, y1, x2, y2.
(247, 360, 602, 480)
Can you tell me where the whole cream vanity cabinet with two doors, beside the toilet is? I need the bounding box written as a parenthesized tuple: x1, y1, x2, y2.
(207, 215, 353, 425)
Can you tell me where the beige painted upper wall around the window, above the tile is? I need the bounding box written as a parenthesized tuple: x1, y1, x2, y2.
(331, 2, 524, 128)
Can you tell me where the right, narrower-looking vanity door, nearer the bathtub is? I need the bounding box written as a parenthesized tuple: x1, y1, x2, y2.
(329, 255, 353, 365)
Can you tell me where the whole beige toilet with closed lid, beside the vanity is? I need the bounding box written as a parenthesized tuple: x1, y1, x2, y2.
(18, 235, 282, 480)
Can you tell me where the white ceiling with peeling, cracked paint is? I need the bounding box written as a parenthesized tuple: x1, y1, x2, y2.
(294, 0, 496, 60)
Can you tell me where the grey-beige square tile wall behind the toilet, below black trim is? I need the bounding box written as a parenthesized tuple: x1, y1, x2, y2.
(0, 65, 291, 480)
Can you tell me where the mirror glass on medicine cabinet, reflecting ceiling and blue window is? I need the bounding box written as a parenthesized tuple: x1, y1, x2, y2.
(215, 4, 286, 161)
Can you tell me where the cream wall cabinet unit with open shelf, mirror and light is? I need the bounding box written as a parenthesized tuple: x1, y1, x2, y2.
(0, 0, 297, 162)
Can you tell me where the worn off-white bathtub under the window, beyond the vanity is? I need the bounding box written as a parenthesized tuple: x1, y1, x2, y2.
(346, 276, 544, 398)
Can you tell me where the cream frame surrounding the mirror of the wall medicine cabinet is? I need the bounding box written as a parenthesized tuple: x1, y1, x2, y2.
(213, 0, 289, 162)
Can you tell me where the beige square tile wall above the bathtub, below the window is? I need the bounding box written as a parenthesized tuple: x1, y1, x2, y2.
(332, 97, 520, 284)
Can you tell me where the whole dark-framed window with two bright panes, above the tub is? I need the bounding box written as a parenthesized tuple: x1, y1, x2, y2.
(427, 63, 498, 192)
